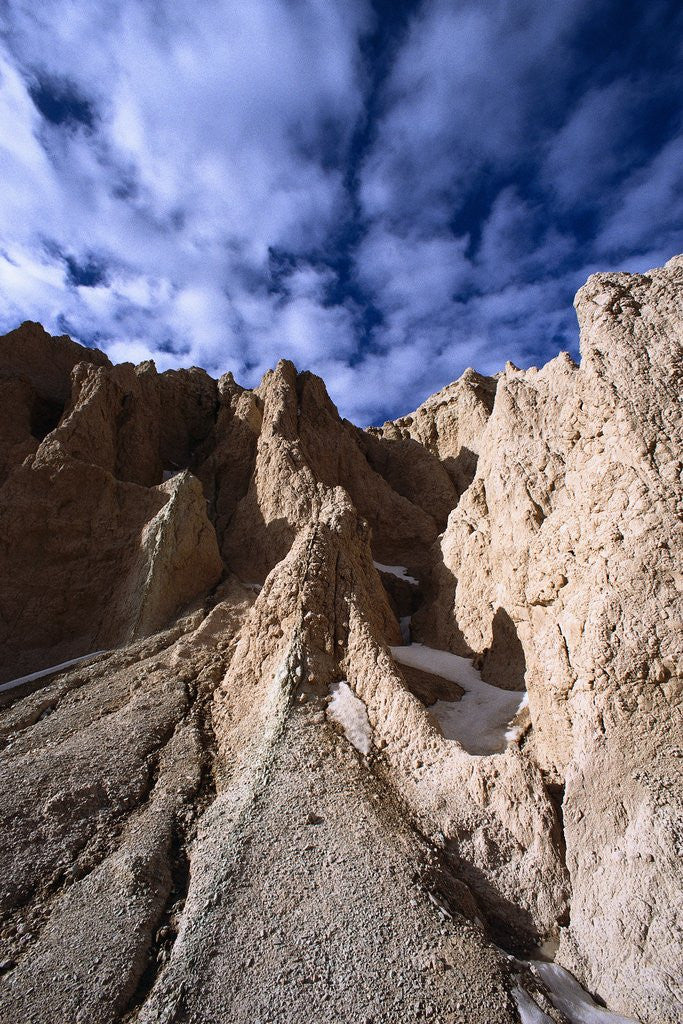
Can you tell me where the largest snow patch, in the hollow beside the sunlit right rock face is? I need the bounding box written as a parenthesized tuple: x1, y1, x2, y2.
(391, 643, 528, 754)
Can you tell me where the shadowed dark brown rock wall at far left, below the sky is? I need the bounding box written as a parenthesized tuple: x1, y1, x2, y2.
(0, 339, 223, 679)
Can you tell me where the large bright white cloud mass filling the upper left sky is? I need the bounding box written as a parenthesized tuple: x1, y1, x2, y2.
(0, 0, 367, 372)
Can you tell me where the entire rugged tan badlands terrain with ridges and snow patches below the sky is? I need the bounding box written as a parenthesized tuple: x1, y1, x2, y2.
(0, 257, 683, 1024)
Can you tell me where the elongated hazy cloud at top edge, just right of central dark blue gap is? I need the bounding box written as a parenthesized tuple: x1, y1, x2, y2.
(361, 0, 585, 223)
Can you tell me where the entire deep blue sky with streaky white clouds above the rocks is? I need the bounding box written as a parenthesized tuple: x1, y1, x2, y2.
(0, 0, 683, 425)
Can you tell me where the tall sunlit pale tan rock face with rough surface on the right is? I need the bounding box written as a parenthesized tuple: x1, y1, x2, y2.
(430, 253, 683, 1020)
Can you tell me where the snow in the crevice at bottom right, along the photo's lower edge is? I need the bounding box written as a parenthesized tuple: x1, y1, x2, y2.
(508, 956, 639, 1024)
